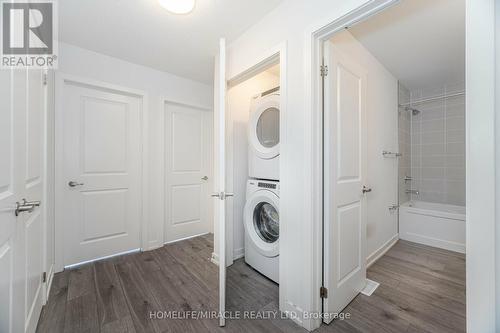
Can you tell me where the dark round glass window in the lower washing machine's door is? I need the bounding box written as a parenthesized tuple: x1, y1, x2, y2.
(253, 202, 279, 243)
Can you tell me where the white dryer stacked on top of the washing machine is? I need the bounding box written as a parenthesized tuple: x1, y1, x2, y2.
(248, 88, 280, 180)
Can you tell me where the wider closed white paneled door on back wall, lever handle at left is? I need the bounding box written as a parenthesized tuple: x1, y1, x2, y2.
(60, 77, 142, 266)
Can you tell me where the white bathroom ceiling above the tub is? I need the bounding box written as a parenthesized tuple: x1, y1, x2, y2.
(349, 0, 465, 89)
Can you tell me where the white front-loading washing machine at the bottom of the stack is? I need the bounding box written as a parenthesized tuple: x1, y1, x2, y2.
(243, 179, 279, 283)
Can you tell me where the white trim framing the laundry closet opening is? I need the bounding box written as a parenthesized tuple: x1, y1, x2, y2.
(225, 41, 288, 314)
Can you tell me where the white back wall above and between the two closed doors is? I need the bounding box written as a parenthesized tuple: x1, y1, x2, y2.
(58, 43, 213, 249)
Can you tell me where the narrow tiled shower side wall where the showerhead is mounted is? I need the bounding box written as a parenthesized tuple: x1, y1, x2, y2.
(398, 84, 411, 204)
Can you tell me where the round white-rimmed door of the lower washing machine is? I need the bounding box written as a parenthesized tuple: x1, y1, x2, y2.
(244, 190, 279, 257)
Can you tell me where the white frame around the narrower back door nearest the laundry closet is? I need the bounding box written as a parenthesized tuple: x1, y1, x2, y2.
(161, 96, 215, 247)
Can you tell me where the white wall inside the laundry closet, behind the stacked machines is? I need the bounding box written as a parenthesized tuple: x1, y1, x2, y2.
(227, 72, 279, 259)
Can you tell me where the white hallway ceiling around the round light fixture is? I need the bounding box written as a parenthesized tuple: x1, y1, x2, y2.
(59, 0, 282, 84)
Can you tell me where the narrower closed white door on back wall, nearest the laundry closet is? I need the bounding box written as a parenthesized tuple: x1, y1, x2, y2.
(165, 103, 213, 242)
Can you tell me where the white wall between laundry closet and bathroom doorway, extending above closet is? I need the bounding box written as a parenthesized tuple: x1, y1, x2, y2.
(227, 0, 394, 329)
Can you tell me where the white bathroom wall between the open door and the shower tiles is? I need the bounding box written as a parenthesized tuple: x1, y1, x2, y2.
(331, 31, 399, 264)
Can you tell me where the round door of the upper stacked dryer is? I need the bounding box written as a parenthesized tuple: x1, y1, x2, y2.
(248, 94, 280, 159)
